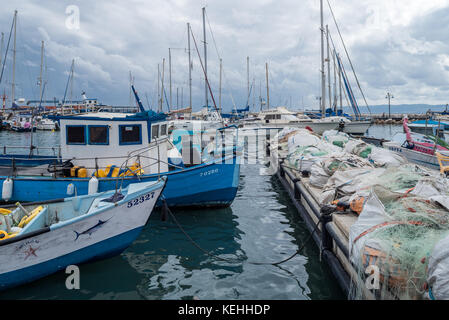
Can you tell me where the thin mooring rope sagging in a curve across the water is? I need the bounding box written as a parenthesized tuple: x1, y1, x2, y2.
(161, 196, 321, 266)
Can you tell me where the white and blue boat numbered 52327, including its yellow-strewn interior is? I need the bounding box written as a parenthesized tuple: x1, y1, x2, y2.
(0, 177, 166, 290)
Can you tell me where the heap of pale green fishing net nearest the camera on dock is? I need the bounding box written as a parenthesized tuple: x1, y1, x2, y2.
(349, 179, 449, 299)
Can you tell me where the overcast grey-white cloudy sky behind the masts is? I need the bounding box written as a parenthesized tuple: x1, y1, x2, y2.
(0, 0, 449, 110)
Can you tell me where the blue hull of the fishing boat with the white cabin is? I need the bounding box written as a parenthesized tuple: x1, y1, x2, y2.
(0, 157, 240, 206)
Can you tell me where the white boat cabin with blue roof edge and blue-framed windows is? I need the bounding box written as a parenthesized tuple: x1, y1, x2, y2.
(59, 111, 169, 176)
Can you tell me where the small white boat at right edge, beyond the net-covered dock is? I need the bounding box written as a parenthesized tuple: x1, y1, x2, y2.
(382, 118, 449, 170)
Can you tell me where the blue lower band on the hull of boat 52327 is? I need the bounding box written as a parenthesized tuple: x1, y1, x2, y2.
(0, 227, 143, 290)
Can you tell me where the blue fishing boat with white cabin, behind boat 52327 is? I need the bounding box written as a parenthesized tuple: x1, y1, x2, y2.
(0, 107, 240, 207)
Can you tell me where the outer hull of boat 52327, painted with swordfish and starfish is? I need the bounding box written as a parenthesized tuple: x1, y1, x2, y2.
(0, 183, 163, 289)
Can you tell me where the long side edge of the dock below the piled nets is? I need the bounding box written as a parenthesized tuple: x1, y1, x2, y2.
(266, 129, 428, 300)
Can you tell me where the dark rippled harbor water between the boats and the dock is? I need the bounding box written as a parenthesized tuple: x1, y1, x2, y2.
(0, 125, 401, 300)
